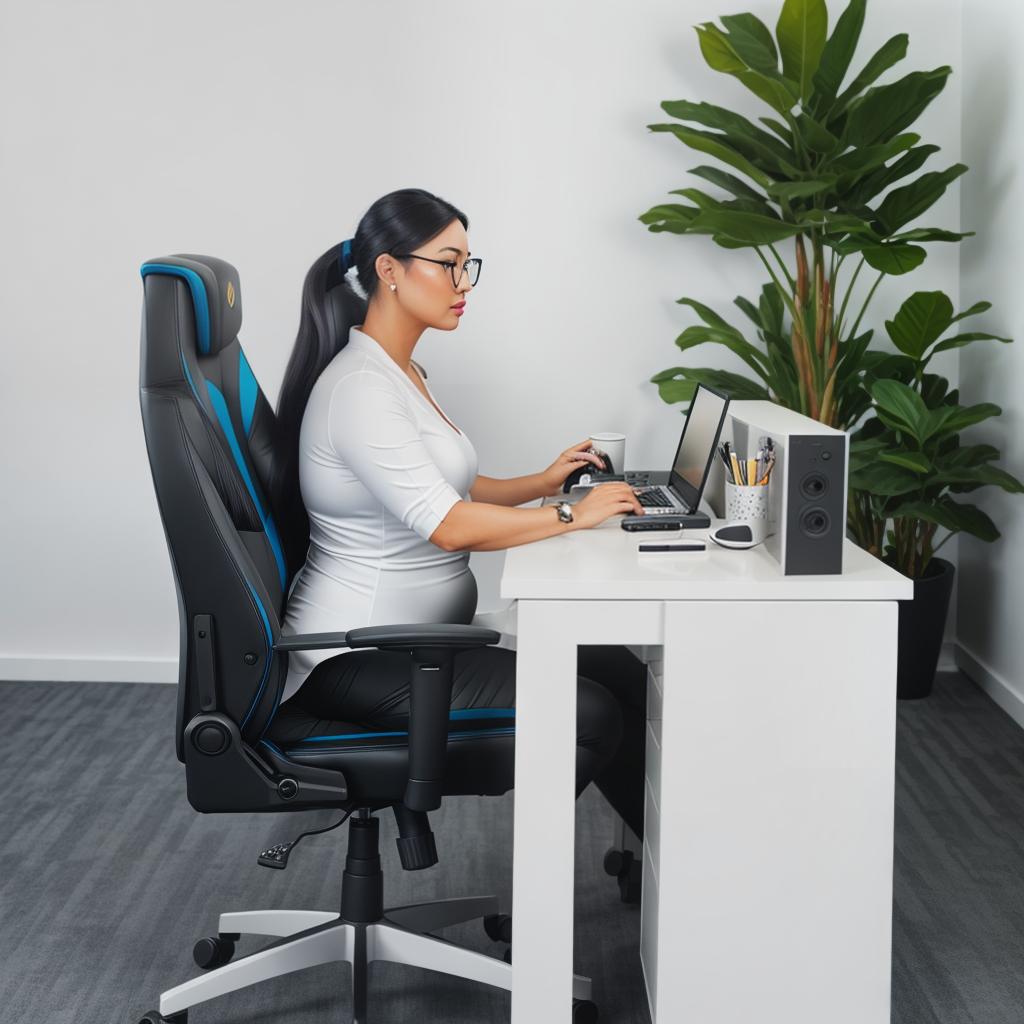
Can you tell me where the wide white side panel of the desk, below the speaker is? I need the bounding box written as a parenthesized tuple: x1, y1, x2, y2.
(655, 601, 897, 1024)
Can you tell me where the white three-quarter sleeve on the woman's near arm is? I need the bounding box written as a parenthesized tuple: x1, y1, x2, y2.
(328, 370, 463, 541)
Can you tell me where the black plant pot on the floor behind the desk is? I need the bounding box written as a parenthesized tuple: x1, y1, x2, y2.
(896, 558, 954, 700)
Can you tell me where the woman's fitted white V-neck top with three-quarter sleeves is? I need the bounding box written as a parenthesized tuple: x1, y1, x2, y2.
(282, 327, 477, 700)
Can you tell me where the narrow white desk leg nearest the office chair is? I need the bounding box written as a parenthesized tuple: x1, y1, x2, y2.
(512, 599, 579, 1024)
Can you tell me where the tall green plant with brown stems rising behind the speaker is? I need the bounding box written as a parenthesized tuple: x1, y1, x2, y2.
(639, 0, 971, 429)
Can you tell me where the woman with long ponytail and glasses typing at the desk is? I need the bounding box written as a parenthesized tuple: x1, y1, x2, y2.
(273, 188, 645, 836)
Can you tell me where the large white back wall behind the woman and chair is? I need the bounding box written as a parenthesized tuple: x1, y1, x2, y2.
(0, 0, 959, 679)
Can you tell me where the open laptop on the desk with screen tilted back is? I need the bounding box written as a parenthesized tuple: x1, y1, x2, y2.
(573, 384, 729, 515)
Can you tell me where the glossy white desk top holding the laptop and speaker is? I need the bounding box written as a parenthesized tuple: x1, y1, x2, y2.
(501, 515, 913, 601)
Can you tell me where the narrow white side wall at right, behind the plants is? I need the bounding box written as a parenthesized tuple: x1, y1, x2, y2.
(957, 0, 1024, 725)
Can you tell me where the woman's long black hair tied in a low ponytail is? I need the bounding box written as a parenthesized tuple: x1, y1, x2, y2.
(270, 188, 469, 564)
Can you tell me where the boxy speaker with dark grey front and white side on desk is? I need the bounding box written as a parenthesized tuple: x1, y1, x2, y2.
(709, 400, 850, 575)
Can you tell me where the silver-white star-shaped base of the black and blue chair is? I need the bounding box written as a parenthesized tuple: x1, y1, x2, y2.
(148, 896, 591, 1024)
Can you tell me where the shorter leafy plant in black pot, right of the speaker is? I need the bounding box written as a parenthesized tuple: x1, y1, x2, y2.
(848, 292, 1024, 698)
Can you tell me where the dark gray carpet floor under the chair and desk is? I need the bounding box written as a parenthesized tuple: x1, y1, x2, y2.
(0, 674, 1024, 1024)
